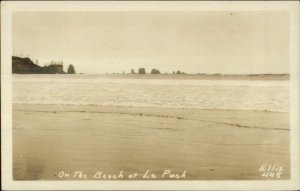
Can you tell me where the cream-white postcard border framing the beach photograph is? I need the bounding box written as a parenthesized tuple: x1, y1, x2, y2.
(1, 1, 300, 190)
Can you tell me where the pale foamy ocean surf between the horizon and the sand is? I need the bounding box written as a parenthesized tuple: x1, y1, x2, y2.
(13, 74, 289, 112)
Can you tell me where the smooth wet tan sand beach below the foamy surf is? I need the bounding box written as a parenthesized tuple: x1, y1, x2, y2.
(13, 104, 290, 180)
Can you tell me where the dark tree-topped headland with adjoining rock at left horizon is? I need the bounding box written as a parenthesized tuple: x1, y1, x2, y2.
(12, 56, 75, 74)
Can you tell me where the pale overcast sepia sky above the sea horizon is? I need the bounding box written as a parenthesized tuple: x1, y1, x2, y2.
(13, 11, 289, 74)
